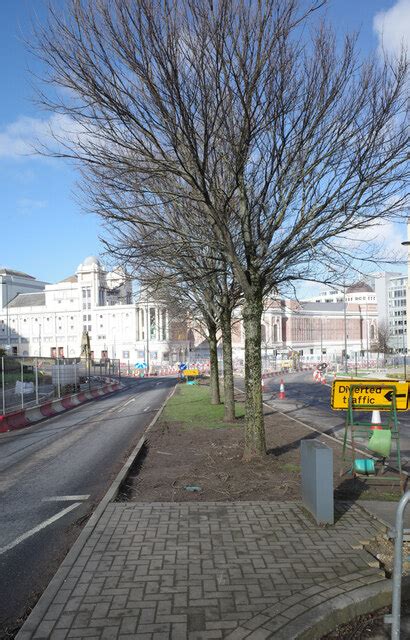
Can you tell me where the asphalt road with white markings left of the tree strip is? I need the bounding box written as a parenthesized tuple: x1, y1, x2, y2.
(0, 378, 175, 638)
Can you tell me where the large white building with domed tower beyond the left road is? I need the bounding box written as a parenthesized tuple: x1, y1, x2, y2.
(0, 256, 189, 366)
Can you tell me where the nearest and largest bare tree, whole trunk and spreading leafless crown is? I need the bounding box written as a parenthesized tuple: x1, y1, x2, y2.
(33, 0, 409, 458)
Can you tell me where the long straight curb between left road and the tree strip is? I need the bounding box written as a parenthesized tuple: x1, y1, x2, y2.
(15, 386, 176, 640)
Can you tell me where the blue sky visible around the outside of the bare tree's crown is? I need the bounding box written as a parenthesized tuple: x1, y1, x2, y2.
(0, 0, 410, 282)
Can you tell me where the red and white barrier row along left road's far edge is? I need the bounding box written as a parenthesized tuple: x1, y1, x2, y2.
(0, 382, 122, 433)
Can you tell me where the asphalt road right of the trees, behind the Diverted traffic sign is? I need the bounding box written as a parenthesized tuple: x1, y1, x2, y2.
(262, 372, 410, 472)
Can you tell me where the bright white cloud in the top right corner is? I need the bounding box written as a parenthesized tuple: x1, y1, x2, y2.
(373, 0, 410, 55)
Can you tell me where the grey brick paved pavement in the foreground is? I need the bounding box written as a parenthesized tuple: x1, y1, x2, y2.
(18, 502, 384, 640)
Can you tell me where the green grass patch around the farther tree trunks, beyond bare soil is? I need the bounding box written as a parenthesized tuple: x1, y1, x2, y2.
(161, 385, 245, 429)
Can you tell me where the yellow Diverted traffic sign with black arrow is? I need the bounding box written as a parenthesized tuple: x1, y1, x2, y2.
(331, 379, 409, 411)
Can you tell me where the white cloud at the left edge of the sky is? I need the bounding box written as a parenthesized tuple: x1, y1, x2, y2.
(0, 114, 82, 158)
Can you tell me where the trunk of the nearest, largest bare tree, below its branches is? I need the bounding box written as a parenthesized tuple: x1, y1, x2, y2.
(243, 294, 266, 460)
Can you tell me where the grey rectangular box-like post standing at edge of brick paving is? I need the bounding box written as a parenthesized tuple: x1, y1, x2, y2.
(300, 440, 334, 524)
